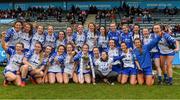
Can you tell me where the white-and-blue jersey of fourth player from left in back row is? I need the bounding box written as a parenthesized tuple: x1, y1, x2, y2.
(44, 33, 57, 48)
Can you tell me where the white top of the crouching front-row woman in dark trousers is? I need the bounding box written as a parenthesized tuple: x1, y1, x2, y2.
(95, 59, 113, 76)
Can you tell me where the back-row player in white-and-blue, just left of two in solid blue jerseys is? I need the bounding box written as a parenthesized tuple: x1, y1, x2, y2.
(97, 27, 108, 52)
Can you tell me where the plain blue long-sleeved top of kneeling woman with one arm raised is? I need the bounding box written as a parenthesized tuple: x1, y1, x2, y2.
(133, 36, 161, 68)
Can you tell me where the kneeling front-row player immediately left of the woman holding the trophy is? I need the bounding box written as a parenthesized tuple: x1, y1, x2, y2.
(63, 43, 78, 84)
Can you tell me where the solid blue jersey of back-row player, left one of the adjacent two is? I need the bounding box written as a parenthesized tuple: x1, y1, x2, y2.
(108, 31, 121, 47)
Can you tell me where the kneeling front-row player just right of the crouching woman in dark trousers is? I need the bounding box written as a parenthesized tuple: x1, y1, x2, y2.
(106, 39, 122, 82)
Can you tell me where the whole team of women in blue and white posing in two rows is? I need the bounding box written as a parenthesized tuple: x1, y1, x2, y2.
(1, 21, 179, 86)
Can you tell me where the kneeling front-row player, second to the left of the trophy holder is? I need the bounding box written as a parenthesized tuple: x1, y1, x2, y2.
(48, 45, 65, 84)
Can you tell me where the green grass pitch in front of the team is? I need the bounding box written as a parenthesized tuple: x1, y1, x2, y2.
(0, 68, 180, 99)
